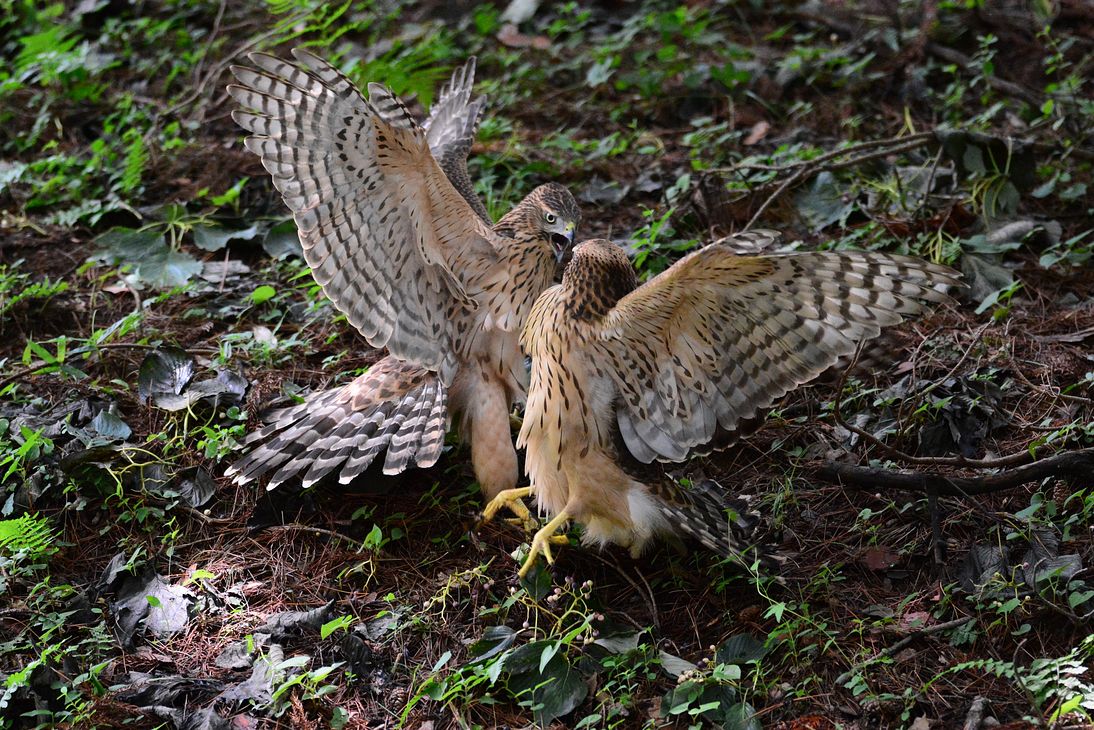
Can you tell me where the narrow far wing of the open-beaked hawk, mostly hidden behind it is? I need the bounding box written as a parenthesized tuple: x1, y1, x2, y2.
(422, 56, 490, 224)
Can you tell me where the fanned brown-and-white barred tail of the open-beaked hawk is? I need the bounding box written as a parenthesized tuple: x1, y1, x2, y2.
(225, 357, 449, 489)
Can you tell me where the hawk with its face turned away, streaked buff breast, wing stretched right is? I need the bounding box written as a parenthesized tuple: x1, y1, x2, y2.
(486, 231, 958, 576)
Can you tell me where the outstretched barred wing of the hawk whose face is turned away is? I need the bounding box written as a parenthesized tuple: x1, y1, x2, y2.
(590, 232, 957, 462)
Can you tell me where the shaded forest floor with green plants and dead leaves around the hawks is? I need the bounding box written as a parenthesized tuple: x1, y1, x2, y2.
(0, 0, 1094, 730)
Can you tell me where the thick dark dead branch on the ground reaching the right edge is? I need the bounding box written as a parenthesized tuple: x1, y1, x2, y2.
(816, 448, 1094, 497)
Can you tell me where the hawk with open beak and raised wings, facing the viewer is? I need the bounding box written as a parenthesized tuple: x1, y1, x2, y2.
(229, 49, 580, 497)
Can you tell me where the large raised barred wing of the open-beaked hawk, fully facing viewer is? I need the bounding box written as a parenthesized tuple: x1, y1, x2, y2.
(229, 49, 500, 384)
